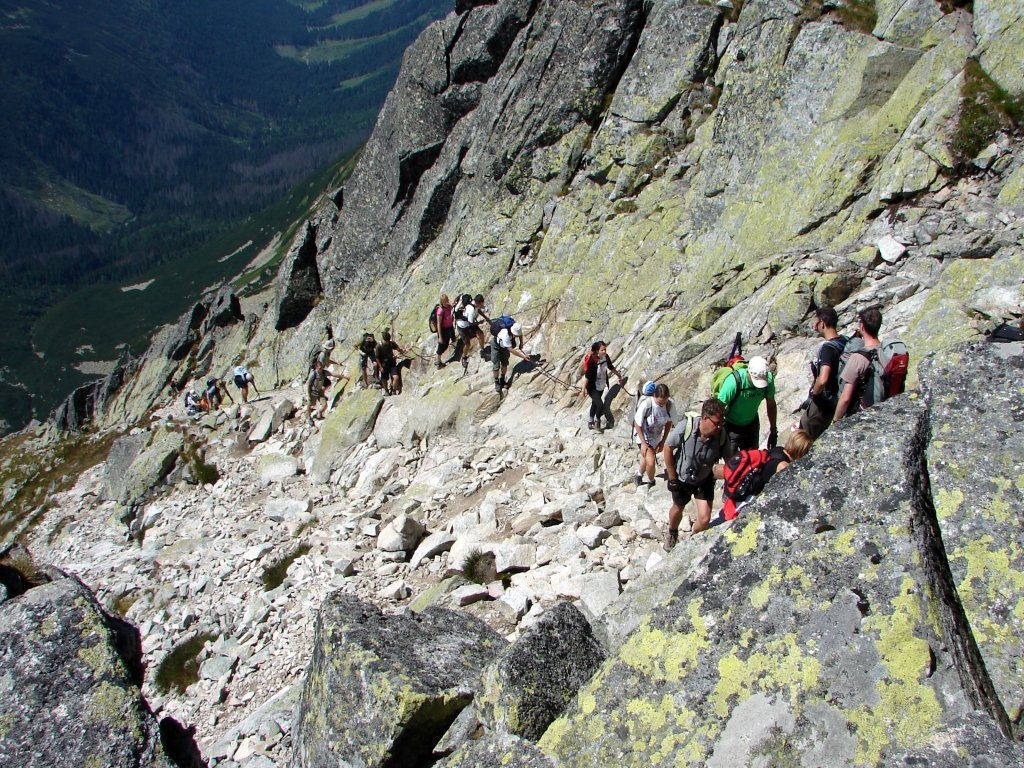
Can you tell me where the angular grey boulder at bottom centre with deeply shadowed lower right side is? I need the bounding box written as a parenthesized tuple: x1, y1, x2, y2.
(294, 592, 506, 768)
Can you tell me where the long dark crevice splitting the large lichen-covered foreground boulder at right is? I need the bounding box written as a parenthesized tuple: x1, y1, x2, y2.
(905, 410, 1013, 739)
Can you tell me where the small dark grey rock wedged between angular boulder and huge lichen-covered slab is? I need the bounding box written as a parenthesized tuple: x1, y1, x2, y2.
(476, 603, 604, 741)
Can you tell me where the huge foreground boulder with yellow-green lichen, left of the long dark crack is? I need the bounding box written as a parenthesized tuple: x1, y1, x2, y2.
(539, 397, 1010, 766)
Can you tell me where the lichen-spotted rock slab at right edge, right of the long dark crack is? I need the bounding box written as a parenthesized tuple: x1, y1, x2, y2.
(921, 342, 1024, 722)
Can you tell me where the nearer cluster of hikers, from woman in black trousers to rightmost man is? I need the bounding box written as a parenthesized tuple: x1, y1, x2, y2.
(614, 306, 909, 550)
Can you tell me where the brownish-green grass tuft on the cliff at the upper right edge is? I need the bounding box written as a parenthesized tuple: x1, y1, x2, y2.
(949, 58, 1024, 166)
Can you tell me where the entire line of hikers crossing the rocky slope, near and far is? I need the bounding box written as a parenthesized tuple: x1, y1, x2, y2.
(180, 294, 908, 550)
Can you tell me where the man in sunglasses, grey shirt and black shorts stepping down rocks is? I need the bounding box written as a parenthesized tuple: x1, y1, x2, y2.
(663, 397, 733, 551)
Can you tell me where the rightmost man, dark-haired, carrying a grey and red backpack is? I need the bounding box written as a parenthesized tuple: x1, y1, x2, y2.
(833, 307, 909, 421)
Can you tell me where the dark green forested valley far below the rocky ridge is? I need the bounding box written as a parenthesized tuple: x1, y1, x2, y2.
(0, 0, 452, 428)
